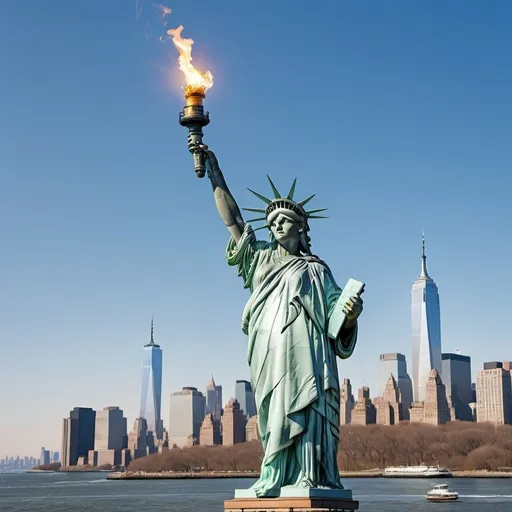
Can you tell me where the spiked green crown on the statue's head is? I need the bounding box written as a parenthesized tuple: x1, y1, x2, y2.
(243, 175, 327, 229)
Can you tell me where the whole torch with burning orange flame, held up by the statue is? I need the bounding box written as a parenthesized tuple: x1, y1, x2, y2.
(167, 25, 213, 178)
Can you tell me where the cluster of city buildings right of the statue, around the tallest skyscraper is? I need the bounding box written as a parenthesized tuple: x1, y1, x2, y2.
(340, 243, 512, 425)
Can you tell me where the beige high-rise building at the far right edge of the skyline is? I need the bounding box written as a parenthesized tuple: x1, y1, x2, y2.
(476, 362, 512, 425)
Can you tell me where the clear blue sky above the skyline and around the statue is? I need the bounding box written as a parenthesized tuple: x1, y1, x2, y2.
(0, 0, 512, 456)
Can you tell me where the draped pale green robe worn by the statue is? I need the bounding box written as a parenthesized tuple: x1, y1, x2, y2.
(226, 224, 357, 496)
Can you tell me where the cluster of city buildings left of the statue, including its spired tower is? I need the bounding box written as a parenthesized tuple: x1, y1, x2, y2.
(59, 320, 259, 467)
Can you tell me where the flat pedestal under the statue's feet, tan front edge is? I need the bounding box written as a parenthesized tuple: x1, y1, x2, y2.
(224, 487, 359, 512)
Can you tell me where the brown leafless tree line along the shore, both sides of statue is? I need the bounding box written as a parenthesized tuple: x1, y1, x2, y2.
(128, 422, 512, 472)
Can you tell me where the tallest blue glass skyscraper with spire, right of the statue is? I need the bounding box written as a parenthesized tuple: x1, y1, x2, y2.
(411, 239, 442, 401)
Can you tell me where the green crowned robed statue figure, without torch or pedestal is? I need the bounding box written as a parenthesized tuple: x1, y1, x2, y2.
(189, 143, 363, 497)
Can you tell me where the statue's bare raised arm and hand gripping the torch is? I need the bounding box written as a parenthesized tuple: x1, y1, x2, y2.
(189, 144, 245, 243)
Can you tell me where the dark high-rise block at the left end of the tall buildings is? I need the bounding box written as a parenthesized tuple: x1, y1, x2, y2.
(62, 407, 96, 466)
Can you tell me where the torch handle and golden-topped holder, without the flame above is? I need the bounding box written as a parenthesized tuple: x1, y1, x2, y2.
(180, 86, 210, 178)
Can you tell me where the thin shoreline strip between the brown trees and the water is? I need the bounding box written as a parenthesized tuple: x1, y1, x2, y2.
(107, 470, 512, 480)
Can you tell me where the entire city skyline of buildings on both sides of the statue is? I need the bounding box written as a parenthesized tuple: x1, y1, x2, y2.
(53, 241, 512, 467)
